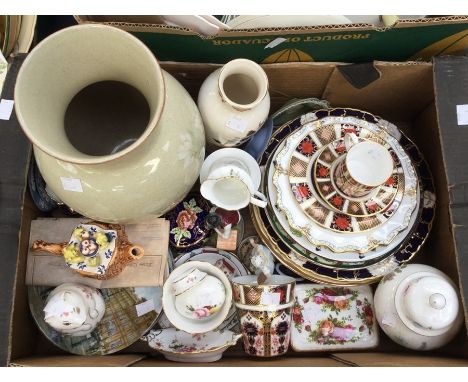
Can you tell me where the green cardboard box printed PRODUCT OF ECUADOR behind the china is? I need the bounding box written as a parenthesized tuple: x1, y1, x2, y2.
(75, 16, 468, 64)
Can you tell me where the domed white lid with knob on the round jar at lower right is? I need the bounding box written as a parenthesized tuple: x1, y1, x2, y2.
(395, 272, 459, 336)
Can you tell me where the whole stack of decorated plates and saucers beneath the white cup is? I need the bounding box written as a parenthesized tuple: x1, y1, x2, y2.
(251, 108, 435, 284)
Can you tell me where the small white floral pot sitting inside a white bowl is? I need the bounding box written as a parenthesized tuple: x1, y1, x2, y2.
(172, 268, 226, 320)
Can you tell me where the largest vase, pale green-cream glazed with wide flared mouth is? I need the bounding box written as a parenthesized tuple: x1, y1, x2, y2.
(15, 24, 205, 223)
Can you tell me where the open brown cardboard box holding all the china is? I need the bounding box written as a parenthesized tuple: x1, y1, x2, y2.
(0, 58, 468, 366)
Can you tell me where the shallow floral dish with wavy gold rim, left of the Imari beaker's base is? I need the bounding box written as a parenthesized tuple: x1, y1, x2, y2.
(142, 328, 241, 362)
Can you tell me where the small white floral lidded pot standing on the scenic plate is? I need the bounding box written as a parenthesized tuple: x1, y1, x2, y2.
(44, 283, 106, 336)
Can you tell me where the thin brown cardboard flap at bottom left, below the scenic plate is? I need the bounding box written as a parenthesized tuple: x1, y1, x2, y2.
(9, 354, 145, 367)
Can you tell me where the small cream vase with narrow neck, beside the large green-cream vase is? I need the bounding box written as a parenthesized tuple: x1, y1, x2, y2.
(198, 58, 270, 147)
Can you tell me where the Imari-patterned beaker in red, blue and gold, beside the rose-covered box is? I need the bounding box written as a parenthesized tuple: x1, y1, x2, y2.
(232, 275, 295, 357)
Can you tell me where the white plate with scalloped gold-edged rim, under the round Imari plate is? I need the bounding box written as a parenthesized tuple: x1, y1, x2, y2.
(273, 116, 418, 253)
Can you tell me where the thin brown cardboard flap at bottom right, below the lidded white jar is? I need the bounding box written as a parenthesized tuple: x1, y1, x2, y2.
(332, 353, 468, 367)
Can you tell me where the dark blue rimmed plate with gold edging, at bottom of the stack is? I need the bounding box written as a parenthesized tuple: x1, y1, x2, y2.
(250, 109, 435, 285)
